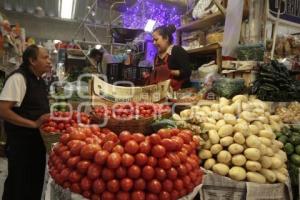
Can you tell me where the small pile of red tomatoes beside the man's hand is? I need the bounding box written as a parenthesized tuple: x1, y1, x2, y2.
(41, 111, 91, 133)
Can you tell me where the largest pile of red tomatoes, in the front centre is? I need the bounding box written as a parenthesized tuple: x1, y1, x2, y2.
(48, 126, 202, 200)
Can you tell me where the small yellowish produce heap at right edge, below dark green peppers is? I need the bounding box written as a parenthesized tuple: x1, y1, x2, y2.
(275, 102, 300, 124)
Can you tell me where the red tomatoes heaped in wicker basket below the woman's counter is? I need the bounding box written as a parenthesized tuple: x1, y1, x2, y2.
(93, 102, 171, 119)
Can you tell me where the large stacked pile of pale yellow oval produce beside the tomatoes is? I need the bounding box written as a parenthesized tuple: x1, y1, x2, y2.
(173, 95, 288, 183)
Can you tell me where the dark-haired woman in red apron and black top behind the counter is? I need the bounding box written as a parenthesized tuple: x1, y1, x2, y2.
(145, 25, 191, 90)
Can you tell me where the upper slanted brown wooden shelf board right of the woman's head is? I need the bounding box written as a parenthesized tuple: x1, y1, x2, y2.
(177, 12, 225, 31)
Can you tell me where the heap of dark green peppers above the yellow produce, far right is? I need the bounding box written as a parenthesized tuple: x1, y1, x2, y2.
(253, 61, 300, 101)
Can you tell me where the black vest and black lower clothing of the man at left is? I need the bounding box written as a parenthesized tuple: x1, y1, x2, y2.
(2, 67, 50, 200)
